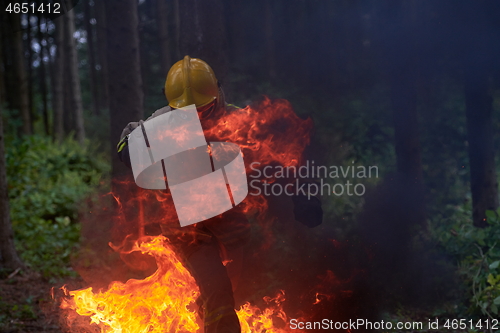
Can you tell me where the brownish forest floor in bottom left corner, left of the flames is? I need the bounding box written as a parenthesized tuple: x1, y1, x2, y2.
(0, 272, 83, 333)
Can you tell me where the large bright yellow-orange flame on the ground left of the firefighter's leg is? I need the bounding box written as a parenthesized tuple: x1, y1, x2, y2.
(61, 236, 199, 333)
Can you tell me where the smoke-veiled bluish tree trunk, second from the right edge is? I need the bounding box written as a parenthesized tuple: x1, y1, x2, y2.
(382, 2, 425, 225)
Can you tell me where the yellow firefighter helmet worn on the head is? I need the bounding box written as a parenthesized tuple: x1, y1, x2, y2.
(165, 56, 219, 109)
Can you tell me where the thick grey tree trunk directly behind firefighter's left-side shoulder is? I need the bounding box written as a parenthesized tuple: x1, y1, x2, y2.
(105, 0, 144, 179)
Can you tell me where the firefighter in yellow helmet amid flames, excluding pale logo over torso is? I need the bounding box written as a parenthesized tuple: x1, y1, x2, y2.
(118, 56, 323, 333)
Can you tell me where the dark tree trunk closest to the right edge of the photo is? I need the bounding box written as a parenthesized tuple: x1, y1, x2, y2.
(460, 2, 499, 228)
